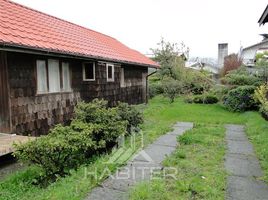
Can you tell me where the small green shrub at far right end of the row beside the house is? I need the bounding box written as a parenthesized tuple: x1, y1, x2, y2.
(117, 102, 143, 133)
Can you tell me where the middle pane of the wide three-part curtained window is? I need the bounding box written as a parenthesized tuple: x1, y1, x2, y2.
(48, 60, 60, 92)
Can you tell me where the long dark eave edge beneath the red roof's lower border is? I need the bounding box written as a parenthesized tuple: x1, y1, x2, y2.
(0, 43, 160, 68)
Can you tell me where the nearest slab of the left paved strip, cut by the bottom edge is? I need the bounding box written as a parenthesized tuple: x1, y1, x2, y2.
(87, 187, 128, 200)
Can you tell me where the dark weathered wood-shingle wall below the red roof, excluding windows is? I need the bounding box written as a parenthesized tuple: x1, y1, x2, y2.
(7, 52, 147, 136)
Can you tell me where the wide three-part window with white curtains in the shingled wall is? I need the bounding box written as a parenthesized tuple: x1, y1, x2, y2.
(36, 59, 71, 94)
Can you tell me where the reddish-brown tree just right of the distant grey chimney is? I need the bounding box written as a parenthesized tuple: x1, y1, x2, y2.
(221, 53, 242, 76)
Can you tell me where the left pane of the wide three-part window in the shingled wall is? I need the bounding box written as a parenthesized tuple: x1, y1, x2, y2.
(36, 60, 47, 93)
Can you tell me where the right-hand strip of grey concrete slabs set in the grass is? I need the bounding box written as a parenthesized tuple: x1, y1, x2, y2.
(225, 125, 268, 200)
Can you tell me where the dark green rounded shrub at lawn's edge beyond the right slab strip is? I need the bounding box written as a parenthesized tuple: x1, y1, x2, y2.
(223, 86, 257, 112)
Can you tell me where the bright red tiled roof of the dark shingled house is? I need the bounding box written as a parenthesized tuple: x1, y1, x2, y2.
(0, 0, 158, 67)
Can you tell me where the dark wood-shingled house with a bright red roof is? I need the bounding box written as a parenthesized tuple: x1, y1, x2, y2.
(0, 0, 158, 135)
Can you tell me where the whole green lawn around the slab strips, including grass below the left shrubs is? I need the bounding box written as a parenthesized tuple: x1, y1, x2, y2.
(0, 97, 268, 200)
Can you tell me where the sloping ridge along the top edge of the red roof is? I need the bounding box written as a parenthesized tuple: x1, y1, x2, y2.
(6, 0, 118, 41)
